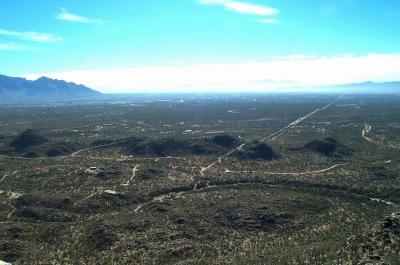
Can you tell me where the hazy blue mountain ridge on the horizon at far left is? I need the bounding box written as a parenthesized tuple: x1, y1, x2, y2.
(0, 75, 102, 104)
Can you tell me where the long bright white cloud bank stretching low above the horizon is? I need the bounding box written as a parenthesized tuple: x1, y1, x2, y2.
(24, 54, 400, 92)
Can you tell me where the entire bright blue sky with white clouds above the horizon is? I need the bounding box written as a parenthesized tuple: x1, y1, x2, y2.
(0, 0, 400, 93)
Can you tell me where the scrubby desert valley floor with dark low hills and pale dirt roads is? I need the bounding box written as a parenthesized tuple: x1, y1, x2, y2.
(0, 94, 400, 264)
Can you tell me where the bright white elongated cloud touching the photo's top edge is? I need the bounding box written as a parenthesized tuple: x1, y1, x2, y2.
(199, 0, 279, 16)
